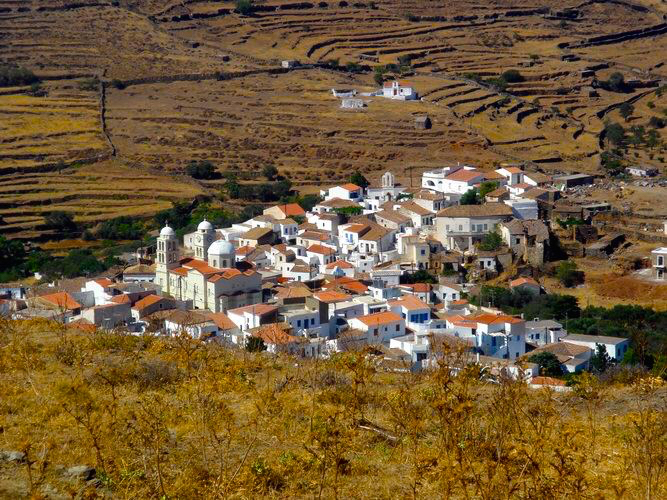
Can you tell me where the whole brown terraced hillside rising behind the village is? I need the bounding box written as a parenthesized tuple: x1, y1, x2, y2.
(0, 0, 667, 235)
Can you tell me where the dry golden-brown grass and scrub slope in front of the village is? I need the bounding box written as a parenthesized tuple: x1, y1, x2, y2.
(0, 322, 667, 499)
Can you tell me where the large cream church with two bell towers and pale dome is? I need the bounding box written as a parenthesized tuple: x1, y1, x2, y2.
(155, 220, 262, 312)
